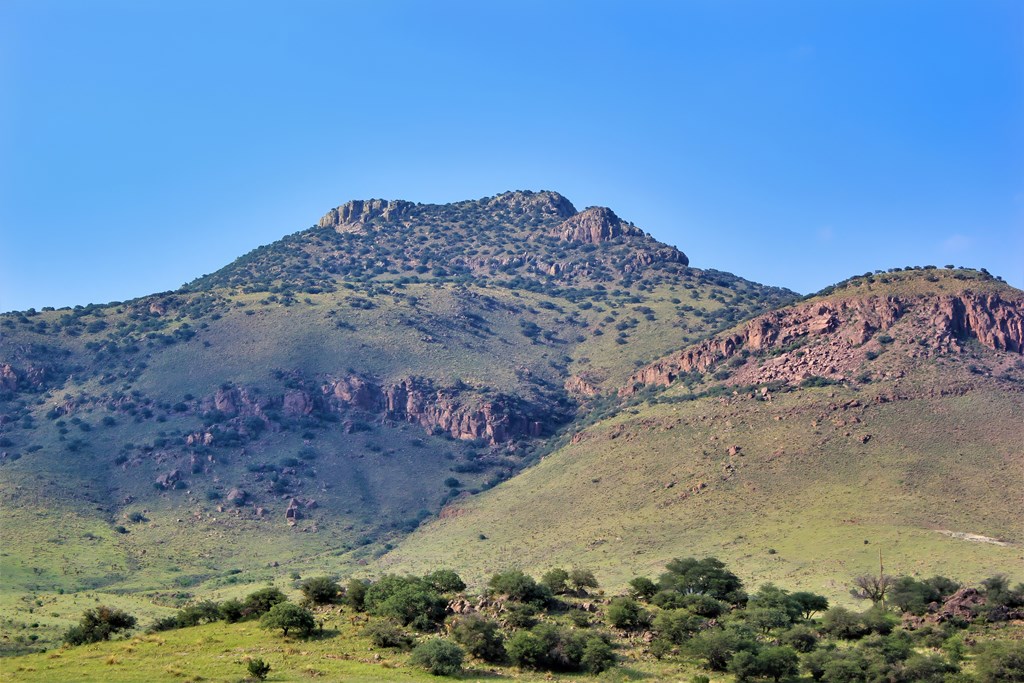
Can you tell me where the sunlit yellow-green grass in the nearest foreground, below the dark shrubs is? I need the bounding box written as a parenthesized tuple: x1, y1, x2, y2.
(0, 608, 725, 683)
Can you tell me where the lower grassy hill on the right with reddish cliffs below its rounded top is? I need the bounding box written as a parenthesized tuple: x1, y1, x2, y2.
(381, 268, 1024, 598)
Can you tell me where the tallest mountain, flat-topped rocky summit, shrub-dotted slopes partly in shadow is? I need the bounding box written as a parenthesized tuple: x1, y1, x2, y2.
(0, 191, 797, 655)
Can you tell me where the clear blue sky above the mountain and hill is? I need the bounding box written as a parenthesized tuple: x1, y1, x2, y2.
(0, 0, 1024, 310)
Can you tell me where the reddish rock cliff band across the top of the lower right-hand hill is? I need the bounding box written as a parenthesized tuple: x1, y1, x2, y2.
(618, 292, 1024, 396)
